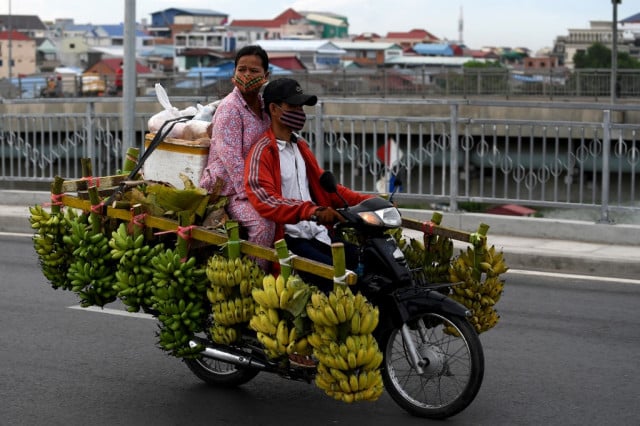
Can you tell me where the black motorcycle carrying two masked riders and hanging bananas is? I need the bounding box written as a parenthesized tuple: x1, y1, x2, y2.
(184, 172, 484, 419)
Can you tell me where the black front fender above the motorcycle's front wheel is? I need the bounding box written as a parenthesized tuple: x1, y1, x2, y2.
(390, 287, 471, 326)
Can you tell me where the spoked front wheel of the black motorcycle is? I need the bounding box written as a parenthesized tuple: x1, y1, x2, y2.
(381, 313, 484, 419)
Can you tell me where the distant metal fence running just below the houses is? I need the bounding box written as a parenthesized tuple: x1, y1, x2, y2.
(4, 67, 640, 100)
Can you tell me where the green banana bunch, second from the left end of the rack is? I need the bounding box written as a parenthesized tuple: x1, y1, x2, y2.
(63, 216, 117, 307)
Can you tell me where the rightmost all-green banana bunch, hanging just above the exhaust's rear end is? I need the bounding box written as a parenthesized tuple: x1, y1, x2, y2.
(150, 249, 208, 357)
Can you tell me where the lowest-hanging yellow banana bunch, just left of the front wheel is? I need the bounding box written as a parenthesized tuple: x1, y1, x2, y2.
(307, 285, 383, 403)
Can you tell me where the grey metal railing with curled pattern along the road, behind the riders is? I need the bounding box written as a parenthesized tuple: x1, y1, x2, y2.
(0, 98, 640, 221)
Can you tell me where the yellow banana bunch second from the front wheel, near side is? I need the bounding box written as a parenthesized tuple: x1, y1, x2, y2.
(249, 274, 311, 359)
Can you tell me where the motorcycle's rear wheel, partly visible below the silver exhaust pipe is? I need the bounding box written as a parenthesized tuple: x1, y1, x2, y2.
(184, 357, 260, 388)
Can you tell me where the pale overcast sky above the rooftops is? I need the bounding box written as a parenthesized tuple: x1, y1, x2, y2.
(5, 0, 640, 52)
